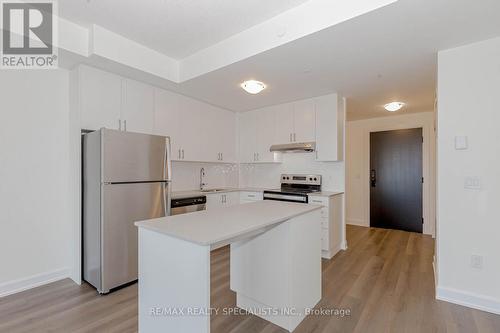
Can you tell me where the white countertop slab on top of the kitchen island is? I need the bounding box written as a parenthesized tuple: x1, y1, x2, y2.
(135, 200, 322, 245)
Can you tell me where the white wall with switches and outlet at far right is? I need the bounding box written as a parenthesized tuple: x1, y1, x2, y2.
(436, 38, 500, 313)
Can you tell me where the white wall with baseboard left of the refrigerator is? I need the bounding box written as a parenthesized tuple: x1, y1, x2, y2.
(0, 70, 72, 296)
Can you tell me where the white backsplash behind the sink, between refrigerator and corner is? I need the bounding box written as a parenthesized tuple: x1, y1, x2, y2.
(172, 161, 238, 191)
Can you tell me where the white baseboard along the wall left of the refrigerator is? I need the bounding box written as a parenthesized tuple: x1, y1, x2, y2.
(0, 268, 70, 297)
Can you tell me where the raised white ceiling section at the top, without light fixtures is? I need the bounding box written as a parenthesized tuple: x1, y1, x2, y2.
(59, 0, 307, 59)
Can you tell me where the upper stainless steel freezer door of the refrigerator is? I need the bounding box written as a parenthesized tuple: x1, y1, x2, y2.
(101, 129, 171, 183)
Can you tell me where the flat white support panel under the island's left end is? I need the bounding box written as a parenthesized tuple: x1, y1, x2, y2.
(139, 227, 210, 333)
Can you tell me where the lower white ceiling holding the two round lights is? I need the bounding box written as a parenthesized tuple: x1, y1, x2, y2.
(174, 0, 500, 120)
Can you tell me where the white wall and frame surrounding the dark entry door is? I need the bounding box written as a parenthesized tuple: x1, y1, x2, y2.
(346, 112, 436, 235)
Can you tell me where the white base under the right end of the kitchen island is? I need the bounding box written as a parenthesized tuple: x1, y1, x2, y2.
(230, 210, 321, 332)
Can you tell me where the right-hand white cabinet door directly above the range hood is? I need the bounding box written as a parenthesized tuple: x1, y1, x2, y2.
(292, 99, 316, 142)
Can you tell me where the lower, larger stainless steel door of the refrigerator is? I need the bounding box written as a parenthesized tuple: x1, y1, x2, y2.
(99, 182, 170, 293)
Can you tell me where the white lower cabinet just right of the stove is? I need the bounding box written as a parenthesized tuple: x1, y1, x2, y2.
(309, 195, 344, 259)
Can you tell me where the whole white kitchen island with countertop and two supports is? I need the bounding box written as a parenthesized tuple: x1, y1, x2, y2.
(136, 201, 321, 333)
